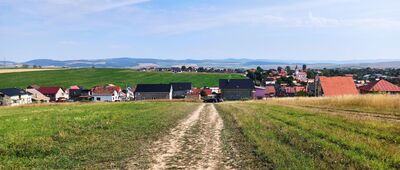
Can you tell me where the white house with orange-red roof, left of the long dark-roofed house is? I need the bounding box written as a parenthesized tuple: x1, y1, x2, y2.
(91, 84, 123, 102)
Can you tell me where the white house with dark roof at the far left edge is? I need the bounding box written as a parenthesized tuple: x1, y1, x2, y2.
(0, 88, 32, 106)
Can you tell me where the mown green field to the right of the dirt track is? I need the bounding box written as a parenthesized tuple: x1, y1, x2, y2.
(216, 96, 400, 169)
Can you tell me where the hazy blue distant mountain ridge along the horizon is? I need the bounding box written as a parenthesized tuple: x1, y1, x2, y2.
(0, 58, 400, 68)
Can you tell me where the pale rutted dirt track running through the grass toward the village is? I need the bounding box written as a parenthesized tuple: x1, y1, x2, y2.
(127, 104, 232, 169)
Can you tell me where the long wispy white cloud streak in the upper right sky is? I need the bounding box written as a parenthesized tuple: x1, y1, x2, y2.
(153, 0, 400, 34)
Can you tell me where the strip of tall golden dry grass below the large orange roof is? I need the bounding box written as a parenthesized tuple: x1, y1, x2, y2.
(269, 95, 400, 115)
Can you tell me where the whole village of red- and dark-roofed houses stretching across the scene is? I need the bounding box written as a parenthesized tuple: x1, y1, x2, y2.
(0, 65, 400, 106)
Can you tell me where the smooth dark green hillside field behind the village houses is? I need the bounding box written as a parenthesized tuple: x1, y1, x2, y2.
(0, 68, 244, 88)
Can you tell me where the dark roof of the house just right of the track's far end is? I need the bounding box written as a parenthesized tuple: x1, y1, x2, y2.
(219, 79, 254, 89)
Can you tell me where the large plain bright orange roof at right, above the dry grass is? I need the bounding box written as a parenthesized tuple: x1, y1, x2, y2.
(319, 76, 358, 96)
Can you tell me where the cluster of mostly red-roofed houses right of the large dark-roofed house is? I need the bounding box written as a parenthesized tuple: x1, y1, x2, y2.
(246, 65, 400, 99)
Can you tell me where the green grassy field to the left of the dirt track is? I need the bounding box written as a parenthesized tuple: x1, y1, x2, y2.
(0, 103, 198, 169)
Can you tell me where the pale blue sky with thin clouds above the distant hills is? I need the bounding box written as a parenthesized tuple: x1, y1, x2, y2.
(0, 0, 400, 61)
